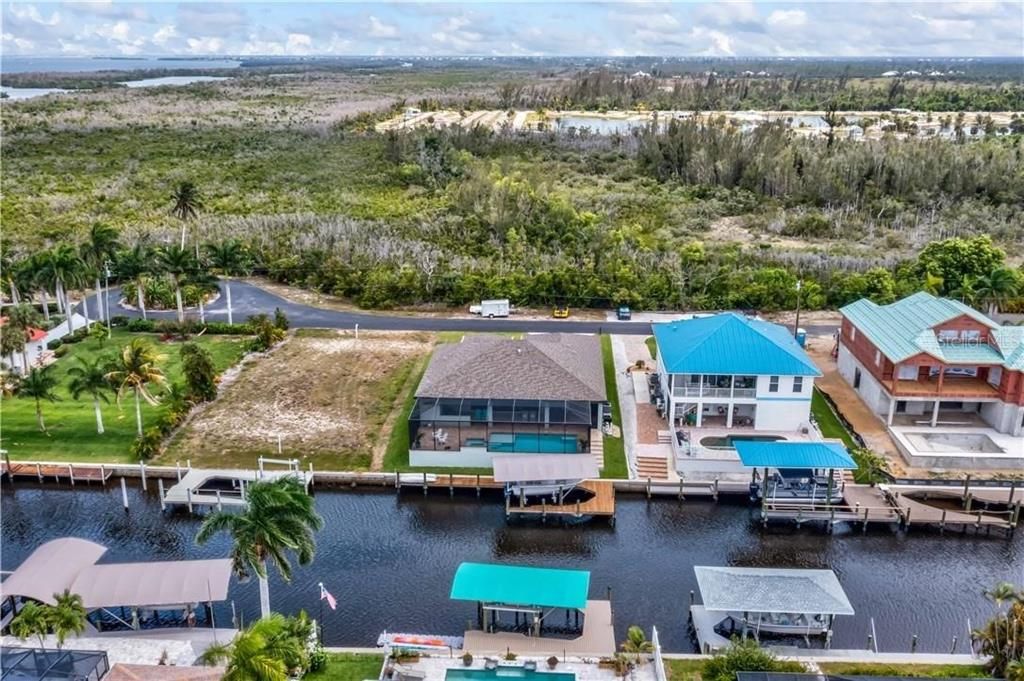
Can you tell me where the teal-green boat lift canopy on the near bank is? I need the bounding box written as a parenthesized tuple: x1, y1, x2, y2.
(451, 563, 590, 610)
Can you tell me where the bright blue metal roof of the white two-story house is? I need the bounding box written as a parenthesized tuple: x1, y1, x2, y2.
(651, 312, 821, 376)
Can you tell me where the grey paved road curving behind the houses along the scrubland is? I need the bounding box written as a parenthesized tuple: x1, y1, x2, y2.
(79, 282, 836, 336)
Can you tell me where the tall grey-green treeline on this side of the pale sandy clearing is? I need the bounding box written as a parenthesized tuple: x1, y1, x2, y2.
(637, 120, 1024, 207)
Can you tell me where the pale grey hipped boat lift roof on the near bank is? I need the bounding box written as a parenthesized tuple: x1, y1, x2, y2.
(693, 565, 853, 615)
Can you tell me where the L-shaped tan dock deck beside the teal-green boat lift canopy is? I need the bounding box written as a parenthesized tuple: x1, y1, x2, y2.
(463, 600, 617, 669)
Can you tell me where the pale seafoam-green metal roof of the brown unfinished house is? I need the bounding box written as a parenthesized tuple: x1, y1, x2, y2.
(840, 292, 1024, 369)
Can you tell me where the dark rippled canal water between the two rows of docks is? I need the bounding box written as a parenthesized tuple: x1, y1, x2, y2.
(0, 481, 1024, 652)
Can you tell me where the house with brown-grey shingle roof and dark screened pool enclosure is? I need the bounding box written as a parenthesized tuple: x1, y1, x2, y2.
(409, 334, 607, 467)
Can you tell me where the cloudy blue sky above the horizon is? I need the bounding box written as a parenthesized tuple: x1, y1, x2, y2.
(0, 0, 1024, 56)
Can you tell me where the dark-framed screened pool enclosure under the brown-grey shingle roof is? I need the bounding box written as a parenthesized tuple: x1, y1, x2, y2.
(409, 397, 601, 454)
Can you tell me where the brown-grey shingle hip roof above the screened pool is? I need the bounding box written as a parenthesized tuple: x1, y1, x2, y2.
(416, 334, 607, 401)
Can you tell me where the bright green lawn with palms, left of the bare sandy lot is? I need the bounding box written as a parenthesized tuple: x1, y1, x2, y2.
(0, 330, 247, 463)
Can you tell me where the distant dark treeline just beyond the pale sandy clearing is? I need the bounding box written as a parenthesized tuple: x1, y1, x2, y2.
(498, 69, 1024, 112)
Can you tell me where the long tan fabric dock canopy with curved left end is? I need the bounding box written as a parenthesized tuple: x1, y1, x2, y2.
(0, 538, 231, 609)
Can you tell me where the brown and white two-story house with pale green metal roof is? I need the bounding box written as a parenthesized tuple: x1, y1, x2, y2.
(838, 293, 1024, 435)
